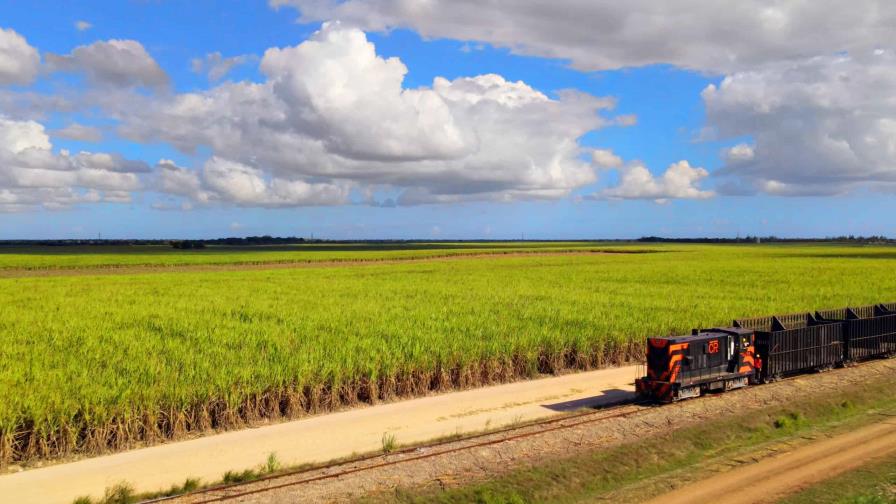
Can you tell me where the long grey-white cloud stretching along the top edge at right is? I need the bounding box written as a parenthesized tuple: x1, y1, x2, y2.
(269, 0, 896, 74)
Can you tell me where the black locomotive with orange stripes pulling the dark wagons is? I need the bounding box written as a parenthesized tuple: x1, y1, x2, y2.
(635, 328, 760, 402)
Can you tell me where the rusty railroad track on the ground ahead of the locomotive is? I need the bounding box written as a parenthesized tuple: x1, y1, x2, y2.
(145, 400, 657, 504)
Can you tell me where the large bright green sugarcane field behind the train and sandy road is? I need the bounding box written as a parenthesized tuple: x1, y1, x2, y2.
(0, 245, 896, 463)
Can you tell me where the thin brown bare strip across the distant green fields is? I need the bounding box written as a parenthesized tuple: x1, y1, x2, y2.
(0, 250, 636, 278)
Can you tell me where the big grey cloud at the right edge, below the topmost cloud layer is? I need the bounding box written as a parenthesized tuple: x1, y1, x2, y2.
(703, 50, 896, 195)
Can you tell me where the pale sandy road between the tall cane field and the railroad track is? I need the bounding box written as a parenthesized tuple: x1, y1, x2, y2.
(0, 366, 637, 504)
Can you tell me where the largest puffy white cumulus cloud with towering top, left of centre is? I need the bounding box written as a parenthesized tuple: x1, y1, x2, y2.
(120, 23, 614, 206)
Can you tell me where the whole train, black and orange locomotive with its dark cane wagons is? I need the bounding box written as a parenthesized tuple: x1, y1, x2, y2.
(635, 303, 896, 402)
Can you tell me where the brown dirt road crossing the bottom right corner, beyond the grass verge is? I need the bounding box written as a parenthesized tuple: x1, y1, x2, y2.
(650, 420, 896, 504)
